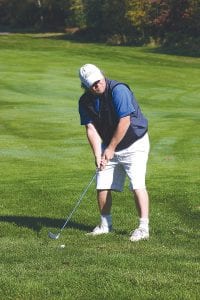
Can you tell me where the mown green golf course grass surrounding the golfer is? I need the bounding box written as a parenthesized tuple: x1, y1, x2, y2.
(0, 35, 200, 300)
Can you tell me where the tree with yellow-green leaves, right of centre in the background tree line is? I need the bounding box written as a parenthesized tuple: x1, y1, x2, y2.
(84, 0, 151, 44)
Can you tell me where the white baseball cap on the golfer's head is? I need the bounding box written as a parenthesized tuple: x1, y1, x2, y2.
(79, 64, 104, 88)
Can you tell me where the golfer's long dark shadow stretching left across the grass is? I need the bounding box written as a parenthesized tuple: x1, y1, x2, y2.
(0, 216, 93, 233)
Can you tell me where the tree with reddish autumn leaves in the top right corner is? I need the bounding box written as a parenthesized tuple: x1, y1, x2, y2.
(152, 0, 200, 49)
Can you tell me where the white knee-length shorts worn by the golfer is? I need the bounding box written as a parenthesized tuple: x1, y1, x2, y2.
(96, 133, 150, 192)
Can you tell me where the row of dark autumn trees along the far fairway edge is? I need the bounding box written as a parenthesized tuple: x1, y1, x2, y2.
(0, 0, 200, 49)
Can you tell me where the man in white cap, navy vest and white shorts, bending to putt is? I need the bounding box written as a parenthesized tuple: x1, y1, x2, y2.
(79, 64, 149, 242)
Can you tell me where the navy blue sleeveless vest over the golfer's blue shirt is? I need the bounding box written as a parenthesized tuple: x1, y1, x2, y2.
(79, 79, 148, 151)
